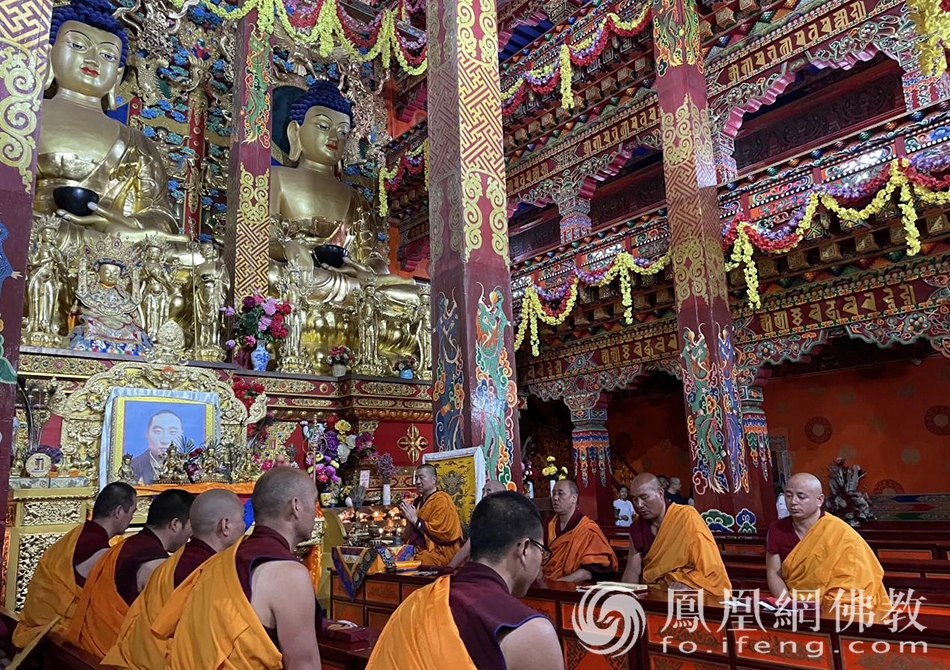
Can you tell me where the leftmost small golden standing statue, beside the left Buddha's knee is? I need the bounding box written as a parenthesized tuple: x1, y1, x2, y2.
(25, 215, 67, 347)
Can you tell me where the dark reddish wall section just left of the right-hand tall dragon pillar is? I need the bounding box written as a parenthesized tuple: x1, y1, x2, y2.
(607, 393, 690, 489)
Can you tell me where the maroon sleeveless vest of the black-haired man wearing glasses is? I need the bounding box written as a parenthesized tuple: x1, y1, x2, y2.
(449, 561, 544, 670)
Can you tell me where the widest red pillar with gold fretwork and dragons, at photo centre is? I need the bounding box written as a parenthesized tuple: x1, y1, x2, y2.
(426, 0, 521, 490)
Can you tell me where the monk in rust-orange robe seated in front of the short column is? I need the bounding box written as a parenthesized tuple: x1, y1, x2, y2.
(544, 479, 617, 582)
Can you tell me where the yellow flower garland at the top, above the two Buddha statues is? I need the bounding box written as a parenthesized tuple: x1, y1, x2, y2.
(172, 0, 428, 75)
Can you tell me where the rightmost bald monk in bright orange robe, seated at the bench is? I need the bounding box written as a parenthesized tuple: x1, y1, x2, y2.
(765, 473, 890, 613)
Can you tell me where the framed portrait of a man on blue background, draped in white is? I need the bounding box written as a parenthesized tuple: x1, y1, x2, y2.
(99, 388, 221, 488)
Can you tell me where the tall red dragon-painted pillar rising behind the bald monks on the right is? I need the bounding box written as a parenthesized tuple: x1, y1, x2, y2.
(653, 0, 764, 530)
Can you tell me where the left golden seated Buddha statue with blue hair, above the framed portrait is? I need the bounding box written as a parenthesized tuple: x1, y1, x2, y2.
(33, 0, 191, 264)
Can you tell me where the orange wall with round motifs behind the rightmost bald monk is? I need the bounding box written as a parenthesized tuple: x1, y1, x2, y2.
(764, 357, 950, 493)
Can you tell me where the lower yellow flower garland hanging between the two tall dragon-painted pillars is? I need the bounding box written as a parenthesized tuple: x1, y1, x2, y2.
(515, 251, 670, 356)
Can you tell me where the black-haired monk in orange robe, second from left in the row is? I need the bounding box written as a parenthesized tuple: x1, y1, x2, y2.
(66, 489, 195, 658)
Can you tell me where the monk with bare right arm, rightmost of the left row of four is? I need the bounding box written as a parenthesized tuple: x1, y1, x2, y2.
(160, 468, 321, 670)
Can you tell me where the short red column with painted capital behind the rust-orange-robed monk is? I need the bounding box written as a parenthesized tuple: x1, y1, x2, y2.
(564, 391, 614, 526)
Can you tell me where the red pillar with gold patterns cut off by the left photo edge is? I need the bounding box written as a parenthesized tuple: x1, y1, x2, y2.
(0, 0, 53, 534)
